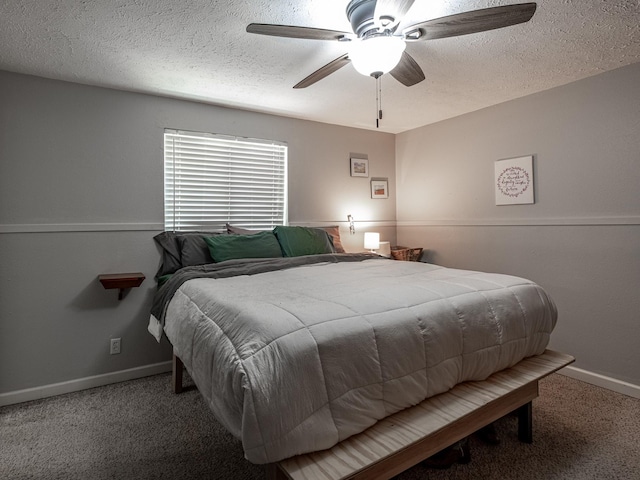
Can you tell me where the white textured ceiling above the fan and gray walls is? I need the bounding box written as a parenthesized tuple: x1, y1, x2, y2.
(0, 0, 640, 133)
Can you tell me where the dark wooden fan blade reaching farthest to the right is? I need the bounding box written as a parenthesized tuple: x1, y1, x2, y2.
(402, 2, 536, 40)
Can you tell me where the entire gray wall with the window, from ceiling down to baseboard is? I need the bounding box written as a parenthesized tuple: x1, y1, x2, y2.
(0, 72, 396, 395)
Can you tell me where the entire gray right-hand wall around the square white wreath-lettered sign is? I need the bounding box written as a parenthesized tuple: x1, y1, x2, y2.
(396, 64, 640, 385)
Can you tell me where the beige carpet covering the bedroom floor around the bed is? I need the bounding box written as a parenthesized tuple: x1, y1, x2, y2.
(0, 374, 640, 480)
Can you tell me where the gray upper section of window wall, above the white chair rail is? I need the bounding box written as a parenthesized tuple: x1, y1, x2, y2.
(0, 72, 396, 230)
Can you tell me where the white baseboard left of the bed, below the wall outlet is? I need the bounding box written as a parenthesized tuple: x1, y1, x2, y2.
(0, 361, 171, 407)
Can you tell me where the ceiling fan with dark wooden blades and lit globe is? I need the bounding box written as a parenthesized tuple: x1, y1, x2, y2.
(247, 0, 536, 88)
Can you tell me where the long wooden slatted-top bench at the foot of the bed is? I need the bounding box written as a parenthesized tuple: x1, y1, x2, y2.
(267, 350, 575, 480)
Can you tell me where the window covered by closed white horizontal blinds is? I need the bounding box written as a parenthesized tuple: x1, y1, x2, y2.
(164, 130, 287, 231)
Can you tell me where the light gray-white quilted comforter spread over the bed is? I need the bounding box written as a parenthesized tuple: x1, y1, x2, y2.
(159, 259, 557, 463)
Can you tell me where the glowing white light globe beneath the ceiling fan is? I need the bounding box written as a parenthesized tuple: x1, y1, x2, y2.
(349, 35, 406, 76)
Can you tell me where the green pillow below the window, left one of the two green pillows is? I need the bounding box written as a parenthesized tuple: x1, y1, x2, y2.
(204, 232, 282, 262)
